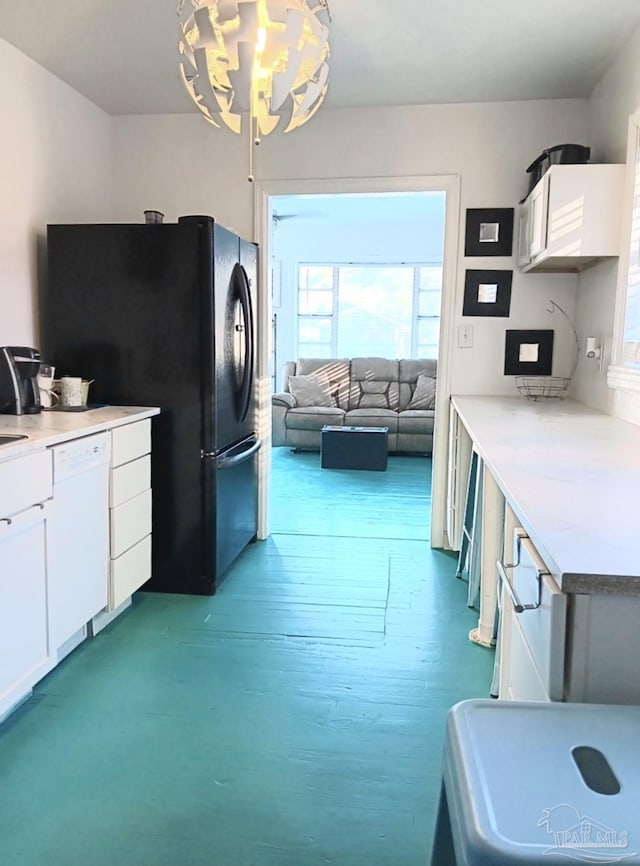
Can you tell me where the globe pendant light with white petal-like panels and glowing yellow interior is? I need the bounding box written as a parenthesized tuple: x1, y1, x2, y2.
(178, 0, 331, 180)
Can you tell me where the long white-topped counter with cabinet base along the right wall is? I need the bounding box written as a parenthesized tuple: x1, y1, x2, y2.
(450, 396, 640, 704)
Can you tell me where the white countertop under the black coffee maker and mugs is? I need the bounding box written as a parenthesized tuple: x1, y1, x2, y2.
(0, 406, 160, 462)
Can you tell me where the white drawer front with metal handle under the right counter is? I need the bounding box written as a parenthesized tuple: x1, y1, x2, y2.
(505, 527, 567, 700)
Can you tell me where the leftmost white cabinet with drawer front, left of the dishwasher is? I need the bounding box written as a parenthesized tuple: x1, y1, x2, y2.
(0, 452, 52, 719)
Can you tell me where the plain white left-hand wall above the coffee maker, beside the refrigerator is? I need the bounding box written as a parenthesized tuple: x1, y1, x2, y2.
(0, 40, 111, 346)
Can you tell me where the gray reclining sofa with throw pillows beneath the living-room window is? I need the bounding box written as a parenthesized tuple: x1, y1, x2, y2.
(271, 358, 437, 454)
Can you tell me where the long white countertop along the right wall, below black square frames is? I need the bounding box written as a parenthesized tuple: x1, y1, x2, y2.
(452, 396, 640, 595)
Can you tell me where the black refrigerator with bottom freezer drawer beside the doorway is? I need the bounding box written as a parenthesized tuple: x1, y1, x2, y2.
(41, 216, 260, 595)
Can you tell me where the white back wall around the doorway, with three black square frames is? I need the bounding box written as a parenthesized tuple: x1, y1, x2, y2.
(114, 100, 589, 394)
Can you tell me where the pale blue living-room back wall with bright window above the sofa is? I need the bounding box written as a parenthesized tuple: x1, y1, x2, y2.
(269, 190, 446, 391)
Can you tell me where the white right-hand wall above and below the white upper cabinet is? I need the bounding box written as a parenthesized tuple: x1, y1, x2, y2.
(574, 28, 640, 423)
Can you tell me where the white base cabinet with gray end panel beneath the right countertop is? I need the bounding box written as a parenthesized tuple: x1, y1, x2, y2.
(498, 509, 640, 705)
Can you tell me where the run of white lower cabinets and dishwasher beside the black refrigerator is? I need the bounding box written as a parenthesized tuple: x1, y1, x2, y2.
(0, 407, 157, 722)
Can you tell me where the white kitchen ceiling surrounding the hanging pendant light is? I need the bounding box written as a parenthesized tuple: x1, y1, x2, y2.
(0, 0, 640, 114)
